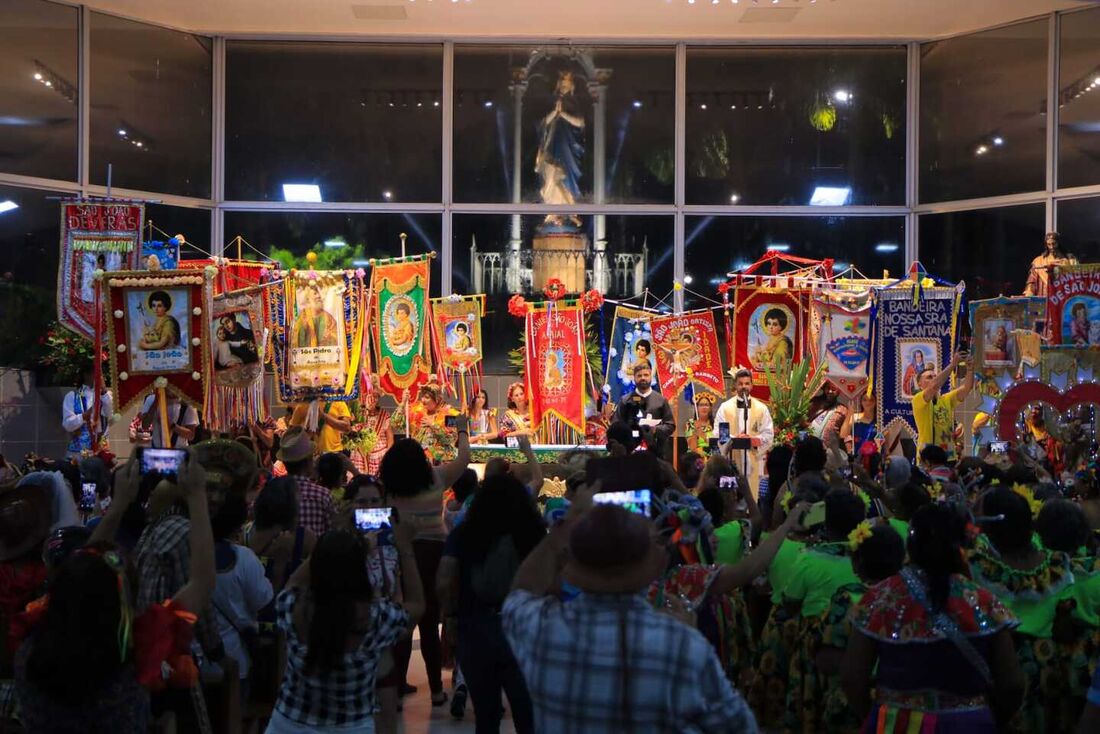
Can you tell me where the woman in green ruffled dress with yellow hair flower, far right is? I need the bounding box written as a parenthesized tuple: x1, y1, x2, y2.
(970, 484, 1100, 732)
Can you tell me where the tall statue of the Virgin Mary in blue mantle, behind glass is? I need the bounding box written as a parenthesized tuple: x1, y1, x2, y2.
(535, 72, 584, 227)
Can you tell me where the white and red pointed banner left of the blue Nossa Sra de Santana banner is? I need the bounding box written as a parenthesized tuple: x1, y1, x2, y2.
(810, 291, 871, 402)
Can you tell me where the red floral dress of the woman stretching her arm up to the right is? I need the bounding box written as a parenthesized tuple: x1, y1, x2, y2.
(646, 563, 752, 686)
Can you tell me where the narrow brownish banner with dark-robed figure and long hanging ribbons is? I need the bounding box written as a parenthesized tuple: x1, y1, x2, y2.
(204, 288, 267, 432)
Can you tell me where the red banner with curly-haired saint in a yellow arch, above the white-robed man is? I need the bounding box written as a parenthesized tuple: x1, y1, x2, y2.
(730, 286, 809, 401)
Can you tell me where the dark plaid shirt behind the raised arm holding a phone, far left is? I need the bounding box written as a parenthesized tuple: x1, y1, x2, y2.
(134, 506, 221, 655)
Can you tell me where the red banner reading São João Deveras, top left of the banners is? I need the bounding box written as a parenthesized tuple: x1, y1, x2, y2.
(57, 200, 145, 339)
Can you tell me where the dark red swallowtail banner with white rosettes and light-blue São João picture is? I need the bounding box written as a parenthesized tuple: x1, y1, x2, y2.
(102, 265, 213, 413)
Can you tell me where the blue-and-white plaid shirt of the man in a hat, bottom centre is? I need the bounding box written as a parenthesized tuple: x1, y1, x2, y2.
(502, 590, 757, 734)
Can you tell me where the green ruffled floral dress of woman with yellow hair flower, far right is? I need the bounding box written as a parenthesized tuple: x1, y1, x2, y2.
(970, 539, 1097, 732)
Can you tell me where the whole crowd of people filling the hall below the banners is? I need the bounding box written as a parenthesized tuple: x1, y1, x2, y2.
(0, 365, 1100, 733)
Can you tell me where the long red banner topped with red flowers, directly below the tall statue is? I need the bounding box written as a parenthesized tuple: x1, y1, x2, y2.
(524, 304, 587, 436)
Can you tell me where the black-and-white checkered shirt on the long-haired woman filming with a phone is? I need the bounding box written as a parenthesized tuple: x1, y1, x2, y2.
(275, 589, 409, 731)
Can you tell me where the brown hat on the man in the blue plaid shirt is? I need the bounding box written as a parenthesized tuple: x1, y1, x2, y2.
(565, 505, 668, 594)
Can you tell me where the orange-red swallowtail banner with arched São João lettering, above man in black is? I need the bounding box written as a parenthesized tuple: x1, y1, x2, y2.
(649, 309, 726, 401)
